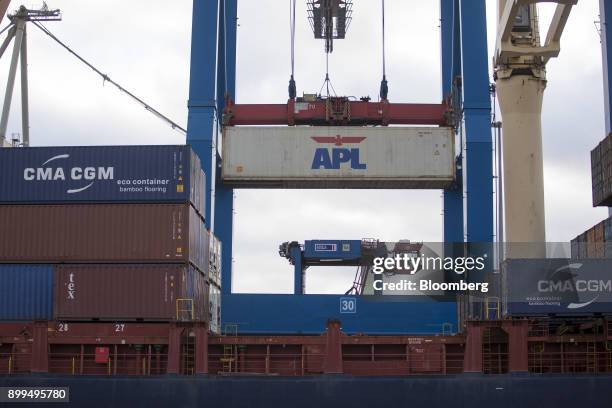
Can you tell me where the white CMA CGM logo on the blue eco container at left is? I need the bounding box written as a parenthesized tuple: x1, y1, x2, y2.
(23, 154, 115, 194)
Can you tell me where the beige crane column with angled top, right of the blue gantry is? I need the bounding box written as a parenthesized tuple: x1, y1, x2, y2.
(494, 0, 578, 258)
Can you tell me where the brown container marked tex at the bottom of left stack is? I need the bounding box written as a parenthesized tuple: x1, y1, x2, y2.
(54, 264, 208, 321)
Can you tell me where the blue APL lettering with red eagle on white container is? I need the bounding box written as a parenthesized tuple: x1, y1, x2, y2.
(311, 135, 368, 170)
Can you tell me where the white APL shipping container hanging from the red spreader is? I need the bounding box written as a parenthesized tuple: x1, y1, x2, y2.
(222, 126, 455, 189)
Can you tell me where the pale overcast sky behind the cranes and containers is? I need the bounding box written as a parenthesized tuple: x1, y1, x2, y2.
(0, 0, 607, 293)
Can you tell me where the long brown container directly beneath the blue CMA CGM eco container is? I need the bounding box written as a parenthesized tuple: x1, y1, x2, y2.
(0, 204, 207, 271)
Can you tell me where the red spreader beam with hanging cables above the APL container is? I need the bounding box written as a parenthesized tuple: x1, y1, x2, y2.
(223, 0, 455, 127)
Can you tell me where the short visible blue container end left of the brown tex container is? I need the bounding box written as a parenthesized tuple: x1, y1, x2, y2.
(0, 265, 53, 321)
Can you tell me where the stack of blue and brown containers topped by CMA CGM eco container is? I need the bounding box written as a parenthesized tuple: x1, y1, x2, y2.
(0, 146, 220, 329)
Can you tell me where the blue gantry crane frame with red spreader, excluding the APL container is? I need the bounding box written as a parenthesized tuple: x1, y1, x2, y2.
(187, 0, 494, 333)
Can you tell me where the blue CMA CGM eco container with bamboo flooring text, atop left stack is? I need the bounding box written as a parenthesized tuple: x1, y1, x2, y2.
(0, 146, 205, 214)
